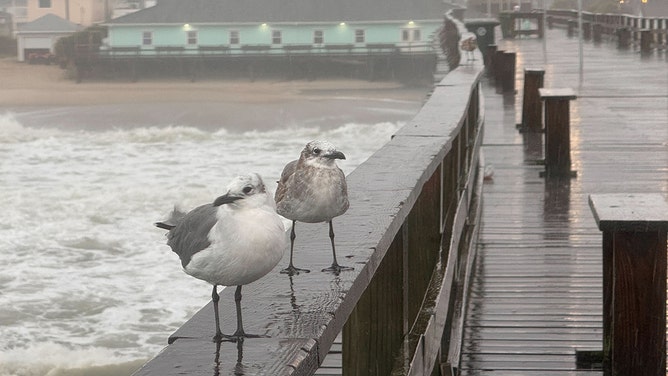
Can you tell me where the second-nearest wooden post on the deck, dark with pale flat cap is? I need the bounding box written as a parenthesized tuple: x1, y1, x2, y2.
(538, 89, 577, 178)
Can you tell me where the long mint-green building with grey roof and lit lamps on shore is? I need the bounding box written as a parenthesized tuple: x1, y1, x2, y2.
(83, 0, 449, 81)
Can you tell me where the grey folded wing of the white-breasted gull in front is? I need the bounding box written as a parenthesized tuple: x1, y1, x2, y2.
(159, 204, 218, 268)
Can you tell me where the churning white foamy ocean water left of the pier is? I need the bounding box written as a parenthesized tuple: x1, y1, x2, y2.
(0, 106, 407, 376)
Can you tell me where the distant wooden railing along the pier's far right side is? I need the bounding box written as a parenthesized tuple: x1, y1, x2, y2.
(547, 10, 668, 52)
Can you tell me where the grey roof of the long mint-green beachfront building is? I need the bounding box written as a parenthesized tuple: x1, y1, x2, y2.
(107, 0, 450, 25)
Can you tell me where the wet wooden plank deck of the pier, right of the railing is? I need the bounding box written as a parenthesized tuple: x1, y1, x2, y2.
(461, 25, 668, 376)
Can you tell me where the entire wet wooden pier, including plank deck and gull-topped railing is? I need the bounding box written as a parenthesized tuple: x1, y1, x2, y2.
(128, 13, 668, 376)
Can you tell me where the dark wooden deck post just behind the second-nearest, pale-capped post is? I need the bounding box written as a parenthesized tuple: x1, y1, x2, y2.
(518, 68, 545, 132)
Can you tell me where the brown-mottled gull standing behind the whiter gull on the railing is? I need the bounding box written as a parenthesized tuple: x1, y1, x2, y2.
(275, 141, 353, 275)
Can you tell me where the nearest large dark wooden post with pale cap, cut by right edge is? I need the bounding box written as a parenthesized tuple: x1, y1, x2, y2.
(589, 194, 668, 376)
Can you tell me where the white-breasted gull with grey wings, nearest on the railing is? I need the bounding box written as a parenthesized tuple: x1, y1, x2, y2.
(155, 173, 288, 342)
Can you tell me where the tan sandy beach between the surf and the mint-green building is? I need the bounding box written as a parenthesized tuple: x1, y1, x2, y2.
(0, 58, 429, 130)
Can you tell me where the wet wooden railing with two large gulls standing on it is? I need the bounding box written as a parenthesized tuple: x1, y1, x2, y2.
(135, 12, 484, 376)
